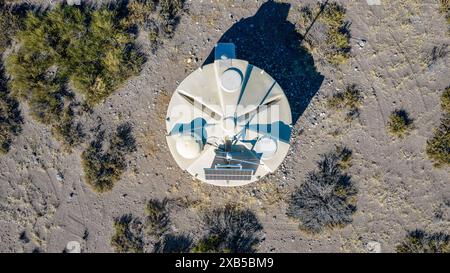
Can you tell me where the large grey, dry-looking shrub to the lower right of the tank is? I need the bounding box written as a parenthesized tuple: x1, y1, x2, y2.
(287, 148, 357, 233)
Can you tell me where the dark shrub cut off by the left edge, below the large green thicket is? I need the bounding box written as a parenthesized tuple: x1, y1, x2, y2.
(0, 66, 23, 154)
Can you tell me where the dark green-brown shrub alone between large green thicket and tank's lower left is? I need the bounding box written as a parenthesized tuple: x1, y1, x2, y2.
(81, 124, 136, 193)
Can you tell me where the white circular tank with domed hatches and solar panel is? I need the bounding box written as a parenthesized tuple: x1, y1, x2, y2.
(166, 44, 292, 186)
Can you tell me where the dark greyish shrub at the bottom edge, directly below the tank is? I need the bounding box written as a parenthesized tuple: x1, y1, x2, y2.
(192, 204, 262, 253)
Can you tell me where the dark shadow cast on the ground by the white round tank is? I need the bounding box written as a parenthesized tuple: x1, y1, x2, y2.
(204, 0, 324, 124)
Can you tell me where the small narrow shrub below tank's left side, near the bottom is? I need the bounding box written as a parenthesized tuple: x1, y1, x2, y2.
(145, 199, 170, 236)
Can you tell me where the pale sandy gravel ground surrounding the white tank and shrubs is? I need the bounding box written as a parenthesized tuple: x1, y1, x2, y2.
(0, 0, 450, 252)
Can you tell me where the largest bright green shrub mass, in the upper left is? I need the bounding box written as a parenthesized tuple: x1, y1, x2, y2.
(6, 5, 143, 146)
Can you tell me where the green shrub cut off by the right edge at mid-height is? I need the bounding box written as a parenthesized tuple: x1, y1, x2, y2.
(427, 87, 450, 167)
